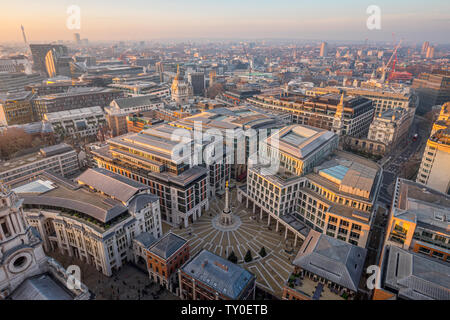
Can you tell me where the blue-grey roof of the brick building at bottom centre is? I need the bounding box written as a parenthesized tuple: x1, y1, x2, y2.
(182, 249, 255, 299)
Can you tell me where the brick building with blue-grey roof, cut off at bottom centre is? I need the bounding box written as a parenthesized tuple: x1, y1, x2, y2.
(178, 249, 256, 300)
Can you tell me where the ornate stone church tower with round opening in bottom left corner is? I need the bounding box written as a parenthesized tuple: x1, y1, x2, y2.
(0, 186, 90, 300)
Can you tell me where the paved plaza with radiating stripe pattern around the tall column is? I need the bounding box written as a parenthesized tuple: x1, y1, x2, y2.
(172, 189, 302, 297)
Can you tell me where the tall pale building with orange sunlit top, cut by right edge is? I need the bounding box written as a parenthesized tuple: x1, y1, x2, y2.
(416, 102, 450, 193)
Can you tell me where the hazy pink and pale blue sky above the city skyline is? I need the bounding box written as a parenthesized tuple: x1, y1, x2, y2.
(0, 0, 450, 43)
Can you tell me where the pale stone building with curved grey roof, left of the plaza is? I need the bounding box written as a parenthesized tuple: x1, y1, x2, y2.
(13, 169, 162, 276)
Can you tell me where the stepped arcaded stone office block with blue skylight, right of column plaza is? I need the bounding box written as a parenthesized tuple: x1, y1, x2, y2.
(238, 151, 381, 248)
